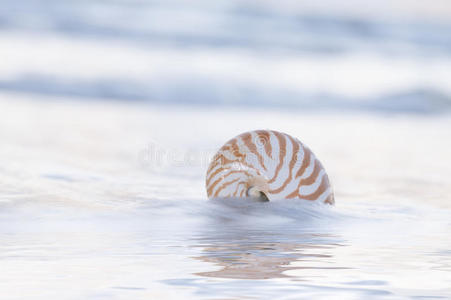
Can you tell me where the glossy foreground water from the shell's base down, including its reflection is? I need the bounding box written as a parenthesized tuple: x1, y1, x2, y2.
(0, 199, 451, 299)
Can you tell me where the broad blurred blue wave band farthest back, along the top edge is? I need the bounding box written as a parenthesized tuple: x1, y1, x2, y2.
(0, 0, 451, 55)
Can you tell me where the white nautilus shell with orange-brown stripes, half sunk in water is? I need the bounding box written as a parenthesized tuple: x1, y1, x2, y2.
(206, 130, 334, 204)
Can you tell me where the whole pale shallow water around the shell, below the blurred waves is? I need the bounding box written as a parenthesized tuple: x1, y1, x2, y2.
(0, 95, 451, 299)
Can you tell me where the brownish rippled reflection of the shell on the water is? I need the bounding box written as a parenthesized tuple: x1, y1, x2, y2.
(195, 232, 347, 279)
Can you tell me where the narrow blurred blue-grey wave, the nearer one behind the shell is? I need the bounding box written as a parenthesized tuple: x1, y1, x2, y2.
(0, 74, 451, 114)
